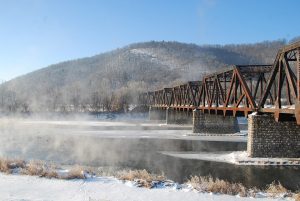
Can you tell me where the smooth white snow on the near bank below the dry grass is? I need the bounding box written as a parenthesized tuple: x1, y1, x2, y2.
(0, 174, 287, 201)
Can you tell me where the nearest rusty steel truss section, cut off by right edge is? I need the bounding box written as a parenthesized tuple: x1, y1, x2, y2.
(258, 42, 300, 122)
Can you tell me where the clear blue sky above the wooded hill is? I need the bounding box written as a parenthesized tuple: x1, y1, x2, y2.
(0, 0, 300, 80)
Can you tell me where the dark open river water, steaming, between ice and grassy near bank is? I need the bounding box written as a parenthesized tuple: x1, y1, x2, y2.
(0, 119, 300, 190)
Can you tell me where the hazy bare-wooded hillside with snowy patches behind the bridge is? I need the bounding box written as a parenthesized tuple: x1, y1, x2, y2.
(0, 40, 285, 112)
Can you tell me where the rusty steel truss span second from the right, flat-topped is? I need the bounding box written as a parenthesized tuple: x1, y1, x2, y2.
(199, 65, 258, 116)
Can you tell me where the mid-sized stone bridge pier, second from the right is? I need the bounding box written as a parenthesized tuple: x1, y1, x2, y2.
(193, 109, 240, 134)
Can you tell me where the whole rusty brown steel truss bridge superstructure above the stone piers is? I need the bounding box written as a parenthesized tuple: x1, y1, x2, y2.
(139, 41, 300, 125)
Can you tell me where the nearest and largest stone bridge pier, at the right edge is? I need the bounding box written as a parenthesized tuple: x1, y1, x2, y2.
(247, 114, 300, 158)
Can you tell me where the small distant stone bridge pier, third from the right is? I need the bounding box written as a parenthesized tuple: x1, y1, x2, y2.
(166, 108, 192, 124)
